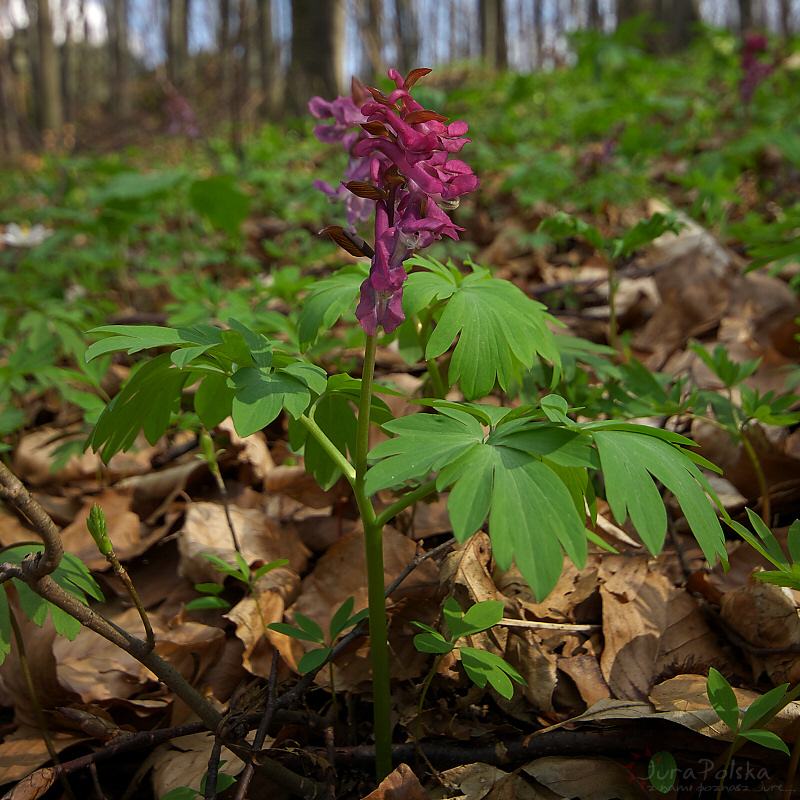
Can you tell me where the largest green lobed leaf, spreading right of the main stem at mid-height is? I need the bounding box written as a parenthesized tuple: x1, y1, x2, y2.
(366, 407, 591, 598)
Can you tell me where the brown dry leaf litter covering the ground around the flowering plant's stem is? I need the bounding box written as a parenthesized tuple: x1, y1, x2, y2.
(0, 152, 800, 800)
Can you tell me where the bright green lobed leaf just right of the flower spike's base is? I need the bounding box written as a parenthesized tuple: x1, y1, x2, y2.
(425, 267, 559, 400)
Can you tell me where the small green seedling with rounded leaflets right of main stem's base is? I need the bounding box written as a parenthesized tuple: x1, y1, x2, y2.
(414, 597, 525, 708)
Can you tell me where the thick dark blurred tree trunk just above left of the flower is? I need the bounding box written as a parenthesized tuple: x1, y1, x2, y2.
(287, 0, 346, 114)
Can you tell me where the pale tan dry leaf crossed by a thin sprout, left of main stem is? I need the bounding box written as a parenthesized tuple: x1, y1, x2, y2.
(178, 503, 308, 583)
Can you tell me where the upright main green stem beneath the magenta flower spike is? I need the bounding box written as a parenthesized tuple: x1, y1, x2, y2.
(353, 334, 392, 781)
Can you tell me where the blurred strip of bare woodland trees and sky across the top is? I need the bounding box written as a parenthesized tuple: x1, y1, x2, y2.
(0, 0, 800, 161)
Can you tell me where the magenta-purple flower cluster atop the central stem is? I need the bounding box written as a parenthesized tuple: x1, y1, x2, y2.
(309, 69, 479, 335)
